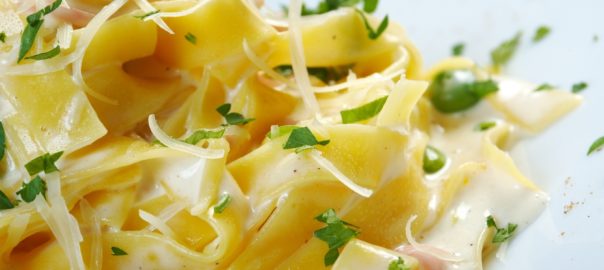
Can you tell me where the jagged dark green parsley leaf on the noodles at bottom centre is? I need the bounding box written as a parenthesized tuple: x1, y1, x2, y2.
(314, 208, 359, 266)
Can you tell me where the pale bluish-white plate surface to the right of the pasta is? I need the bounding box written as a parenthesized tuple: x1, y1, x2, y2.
(378, 0, 604, 269)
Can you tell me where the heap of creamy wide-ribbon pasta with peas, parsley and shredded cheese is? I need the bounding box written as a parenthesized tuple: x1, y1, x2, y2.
(0, 0, 581, 269)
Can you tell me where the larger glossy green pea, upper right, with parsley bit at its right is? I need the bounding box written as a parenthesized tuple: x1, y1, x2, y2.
(430, 69, 499, 113)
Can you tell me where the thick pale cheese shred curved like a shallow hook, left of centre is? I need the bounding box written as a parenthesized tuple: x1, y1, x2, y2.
(148, 114, 224, 159)
